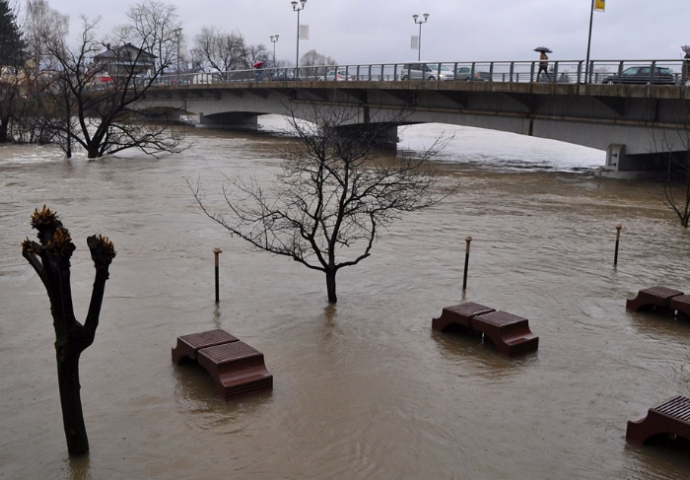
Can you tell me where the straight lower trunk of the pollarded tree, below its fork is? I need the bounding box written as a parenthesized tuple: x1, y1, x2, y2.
(55, 342, 89, 455)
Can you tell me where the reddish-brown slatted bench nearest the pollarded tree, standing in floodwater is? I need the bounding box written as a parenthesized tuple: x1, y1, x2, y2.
(172, 330, 273, 400)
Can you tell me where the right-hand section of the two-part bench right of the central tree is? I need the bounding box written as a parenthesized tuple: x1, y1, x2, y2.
(472, 311, 539, 357)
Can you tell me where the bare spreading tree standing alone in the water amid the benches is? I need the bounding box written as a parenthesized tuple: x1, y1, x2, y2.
(190, 105, 444, 303)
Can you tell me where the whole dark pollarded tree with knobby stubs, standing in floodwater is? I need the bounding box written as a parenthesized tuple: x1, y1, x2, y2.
(22, 206, 115, 454)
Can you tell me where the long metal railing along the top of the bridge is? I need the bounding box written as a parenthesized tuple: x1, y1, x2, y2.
(156, 60, 690, 86)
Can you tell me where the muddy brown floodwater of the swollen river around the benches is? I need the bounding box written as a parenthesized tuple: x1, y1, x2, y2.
(0, 117, 690, 480)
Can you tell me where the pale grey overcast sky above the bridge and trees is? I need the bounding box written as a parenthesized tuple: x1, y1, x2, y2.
(41, 0, 690, 64)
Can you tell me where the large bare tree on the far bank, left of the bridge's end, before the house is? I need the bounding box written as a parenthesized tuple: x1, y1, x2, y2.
(42, 18, 182, 158)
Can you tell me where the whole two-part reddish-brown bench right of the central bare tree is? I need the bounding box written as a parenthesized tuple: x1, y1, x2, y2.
(431, 302, 539, 357)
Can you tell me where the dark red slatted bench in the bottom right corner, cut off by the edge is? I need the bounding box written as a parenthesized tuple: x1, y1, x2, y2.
(625, 395, 690, 445)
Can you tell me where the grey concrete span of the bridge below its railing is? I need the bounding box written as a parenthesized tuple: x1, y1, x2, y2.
(138, 81, 690, 171)
